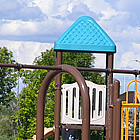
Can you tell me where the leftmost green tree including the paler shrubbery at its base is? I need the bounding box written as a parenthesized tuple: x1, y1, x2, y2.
(0, 47, 17, 138)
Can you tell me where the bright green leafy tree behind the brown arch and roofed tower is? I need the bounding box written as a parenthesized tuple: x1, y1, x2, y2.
(15, 49, 104, 139)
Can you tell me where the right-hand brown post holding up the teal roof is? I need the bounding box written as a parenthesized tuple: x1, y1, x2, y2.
(105, 53, 114, 140)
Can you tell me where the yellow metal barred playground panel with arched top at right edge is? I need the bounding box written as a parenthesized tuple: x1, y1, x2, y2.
(121, 80, 140, 140)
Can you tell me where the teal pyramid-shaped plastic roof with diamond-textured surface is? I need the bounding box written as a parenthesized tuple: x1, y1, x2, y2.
(54, 16, 116, 53)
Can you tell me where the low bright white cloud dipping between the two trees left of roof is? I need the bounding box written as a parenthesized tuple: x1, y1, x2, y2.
(0, 40, 53, 64)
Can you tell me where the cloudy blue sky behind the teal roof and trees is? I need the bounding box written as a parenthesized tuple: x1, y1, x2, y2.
(0, 0, 140, 92)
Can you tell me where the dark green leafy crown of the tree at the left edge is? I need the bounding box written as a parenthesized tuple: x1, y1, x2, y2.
(0, 47, 17, 106)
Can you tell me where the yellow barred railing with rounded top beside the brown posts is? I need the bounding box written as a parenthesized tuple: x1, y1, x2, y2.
(121, 80, 140, 140)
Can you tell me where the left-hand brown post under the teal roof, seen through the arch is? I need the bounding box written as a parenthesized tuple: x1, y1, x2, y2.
(54, 51, 62, 140)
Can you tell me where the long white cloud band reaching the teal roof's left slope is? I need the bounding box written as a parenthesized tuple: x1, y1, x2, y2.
(0, 18, 72, 42)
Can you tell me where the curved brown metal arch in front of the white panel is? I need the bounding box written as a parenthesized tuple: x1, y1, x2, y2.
(36, 65, 90, 140)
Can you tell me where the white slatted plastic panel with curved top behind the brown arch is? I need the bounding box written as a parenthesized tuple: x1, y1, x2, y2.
(61, 81, 106, 125)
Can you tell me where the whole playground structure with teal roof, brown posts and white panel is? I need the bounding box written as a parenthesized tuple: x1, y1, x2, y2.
(0, 16, 140, 140)
